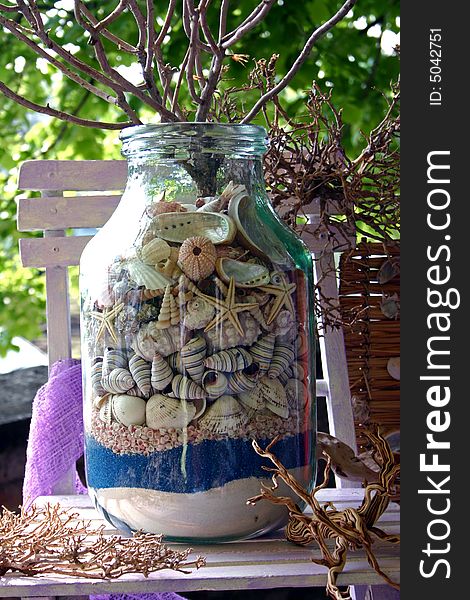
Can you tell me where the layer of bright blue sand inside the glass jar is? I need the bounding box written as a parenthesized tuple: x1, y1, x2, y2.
(86, 432, 312, 493)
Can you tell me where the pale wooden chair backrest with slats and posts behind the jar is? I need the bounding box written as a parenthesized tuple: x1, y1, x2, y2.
(18, 160, 356, 462)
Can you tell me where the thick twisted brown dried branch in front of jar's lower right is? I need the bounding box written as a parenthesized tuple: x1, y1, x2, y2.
(247, 430, 400, 600)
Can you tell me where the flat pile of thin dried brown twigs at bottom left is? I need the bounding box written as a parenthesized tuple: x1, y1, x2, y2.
(0, 504, 205, 579)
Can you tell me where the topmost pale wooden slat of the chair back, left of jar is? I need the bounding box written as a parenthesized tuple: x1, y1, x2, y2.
(18, 160, 127, 192)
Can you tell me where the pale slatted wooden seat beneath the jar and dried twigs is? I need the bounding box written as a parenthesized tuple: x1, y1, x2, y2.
(0, 488, 400, 598)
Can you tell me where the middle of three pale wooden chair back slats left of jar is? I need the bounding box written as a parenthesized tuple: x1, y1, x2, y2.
(18, 195, 121, 231)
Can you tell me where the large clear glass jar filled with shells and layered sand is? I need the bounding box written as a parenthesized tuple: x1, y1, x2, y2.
(80, 123, 315, 541)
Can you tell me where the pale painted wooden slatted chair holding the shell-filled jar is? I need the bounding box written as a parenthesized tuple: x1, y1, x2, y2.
(7, 161, 399, 600)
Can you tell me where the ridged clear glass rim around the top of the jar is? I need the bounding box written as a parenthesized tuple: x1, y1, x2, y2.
(120, 122, 268, 157)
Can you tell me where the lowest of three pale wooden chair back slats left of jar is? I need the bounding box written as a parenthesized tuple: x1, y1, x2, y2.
(20, 235, 93, 268)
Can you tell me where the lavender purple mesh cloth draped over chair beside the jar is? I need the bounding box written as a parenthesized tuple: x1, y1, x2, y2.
(23, 359, 184, 600)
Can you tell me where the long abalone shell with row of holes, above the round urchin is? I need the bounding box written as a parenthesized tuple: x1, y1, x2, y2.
(153, 212, 237, 244)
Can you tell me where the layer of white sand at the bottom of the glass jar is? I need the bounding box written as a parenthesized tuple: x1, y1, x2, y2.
(90, 467, 311, 541)
